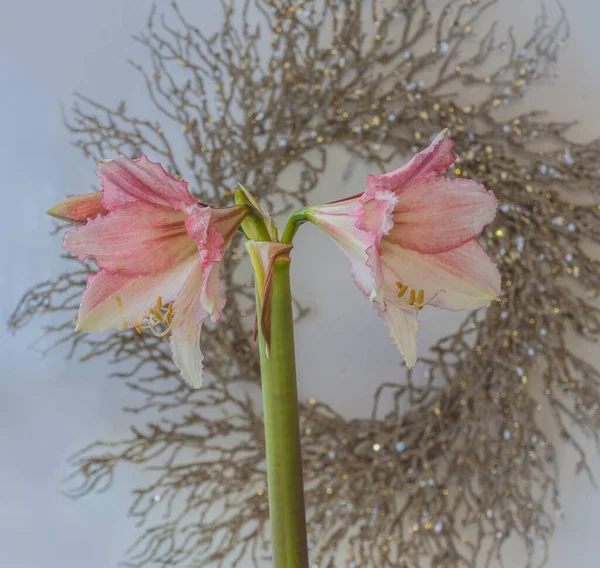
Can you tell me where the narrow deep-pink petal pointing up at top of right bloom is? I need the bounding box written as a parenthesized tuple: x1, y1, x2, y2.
(367, 130, 456, 191)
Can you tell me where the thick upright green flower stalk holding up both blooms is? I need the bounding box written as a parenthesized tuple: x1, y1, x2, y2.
(257, 258, 308, 568)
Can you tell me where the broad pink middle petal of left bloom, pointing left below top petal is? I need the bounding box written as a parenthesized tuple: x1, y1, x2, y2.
(63, 201, 197, 274)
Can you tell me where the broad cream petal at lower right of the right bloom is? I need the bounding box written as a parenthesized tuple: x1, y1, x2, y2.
(382, 240, 500, 310)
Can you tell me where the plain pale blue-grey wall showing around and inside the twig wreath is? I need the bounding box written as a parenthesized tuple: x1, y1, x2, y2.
(0, 0, 600, 568)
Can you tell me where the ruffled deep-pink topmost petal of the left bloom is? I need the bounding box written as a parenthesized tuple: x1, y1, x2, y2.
(98, 156, 197, 211)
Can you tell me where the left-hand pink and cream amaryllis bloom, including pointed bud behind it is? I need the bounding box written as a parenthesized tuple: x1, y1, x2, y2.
(48, 156, 247, 387)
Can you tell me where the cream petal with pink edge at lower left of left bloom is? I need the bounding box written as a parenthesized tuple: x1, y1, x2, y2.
(76, 261, 192, 332)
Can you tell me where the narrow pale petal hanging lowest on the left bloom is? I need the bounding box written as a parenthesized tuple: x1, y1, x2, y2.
(171, 259, 209, 388)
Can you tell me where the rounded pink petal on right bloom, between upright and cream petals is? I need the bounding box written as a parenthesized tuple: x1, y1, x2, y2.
(385, 177, 497, 254)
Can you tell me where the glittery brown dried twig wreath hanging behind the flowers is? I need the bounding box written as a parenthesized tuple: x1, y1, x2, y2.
(11, 0, 600, 568)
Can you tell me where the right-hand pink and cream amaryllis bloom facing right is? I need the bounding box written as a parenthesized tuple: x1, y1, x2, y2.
(307, 132, 500, 367)
